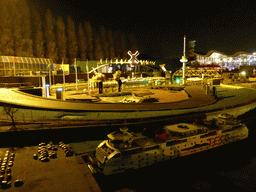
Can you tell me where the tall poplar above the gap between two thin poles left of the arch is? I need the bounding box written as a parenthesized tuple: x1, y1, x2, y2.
(77, 24, 87, 61)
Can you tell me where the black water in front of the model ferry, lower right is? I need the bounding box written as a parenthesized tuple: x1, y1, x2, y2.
(95, 110, 256, 192)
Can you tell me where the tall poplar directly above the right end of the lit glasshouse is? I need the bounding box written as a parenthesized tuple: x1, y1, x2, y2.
(44, 9, 57, 62)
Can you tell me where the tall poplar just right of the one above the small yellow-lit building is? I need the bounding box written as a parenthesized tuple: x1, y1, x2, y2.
(67, 16, 78, 64)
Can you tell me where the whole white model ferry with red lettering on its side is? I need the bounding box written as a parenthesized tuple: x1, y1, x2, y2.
(88, 114, 248, 175)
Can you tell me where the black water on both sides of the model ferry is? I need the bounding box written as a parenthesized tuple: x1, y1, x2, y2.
(0, 110, 256, 192)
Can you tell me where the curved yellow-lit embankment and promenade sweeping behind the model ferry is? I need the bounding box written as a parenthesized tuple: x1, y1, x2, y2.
(0, 85, 256, 130)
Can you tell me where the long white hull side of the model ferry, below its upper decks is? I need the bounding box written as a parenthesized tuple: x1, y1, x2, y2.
(88, 121, 248, 175)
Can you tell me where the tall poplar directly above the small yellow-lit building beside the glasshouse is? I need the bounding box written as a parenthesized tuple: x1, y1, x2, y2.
(56, 15, 67, 63)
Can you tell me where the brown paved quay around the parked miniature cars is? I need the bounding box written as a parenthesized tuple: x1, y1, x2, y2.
(0, 146, 101, 192)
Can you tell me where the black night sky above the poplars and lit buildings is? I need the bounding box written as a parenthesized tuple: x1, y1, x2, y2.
(36, 0, 256, 58)
